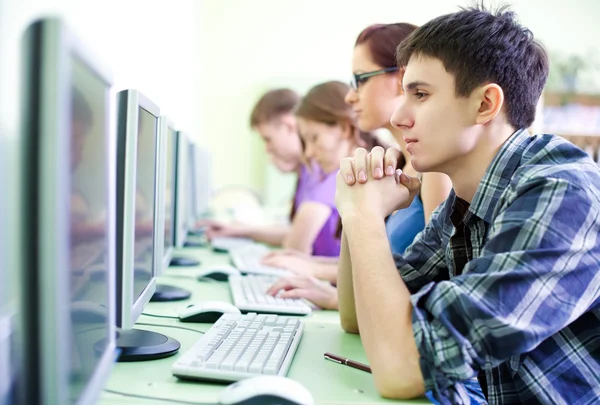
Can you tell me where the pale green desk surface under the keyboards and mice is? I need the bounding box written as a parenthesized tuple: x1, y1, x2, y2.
(98, 245, 430, 405)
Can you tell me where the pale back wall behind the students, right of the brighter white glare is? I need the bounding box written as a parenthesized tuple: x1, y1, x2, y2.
(196, 0, 600, 197)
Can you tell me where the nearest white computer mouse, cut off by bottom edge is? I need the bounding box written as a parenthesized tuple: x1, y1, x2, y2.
(219, 375, 315, 405)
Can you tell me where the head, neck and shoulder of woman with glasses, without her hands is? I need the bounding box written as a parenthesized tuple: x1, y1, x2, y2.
(346, 23, 452, 253)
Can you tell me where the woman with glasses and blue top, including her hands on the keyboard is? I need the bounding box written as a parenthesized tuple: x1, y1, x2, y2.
(265, 23, 452, 278)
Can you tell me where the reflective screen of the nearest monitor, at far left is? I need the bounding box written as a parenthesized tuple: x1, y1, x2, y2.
(69, 57, 109, 400)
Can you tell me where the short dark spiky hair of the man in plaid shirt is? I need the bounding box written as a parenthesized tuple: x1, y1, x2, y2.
(397, 5, 548, 129)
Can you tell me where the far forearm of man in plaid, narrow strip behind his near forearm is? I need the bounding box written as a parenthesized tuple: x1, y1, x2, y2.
(337, 232, 358, 333)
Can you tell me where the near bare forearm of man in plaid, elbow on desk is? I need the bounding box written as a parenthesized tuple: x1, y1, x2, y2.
(340, 216, 425, 399)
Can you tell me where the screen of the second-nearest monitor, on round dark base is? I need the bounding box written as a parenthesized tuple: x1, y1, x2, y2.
(133, 107, 158, 302)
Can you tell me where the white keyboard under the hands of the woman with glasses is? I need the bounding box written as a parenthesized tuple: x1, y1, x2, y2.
(229, 275, 312, 315)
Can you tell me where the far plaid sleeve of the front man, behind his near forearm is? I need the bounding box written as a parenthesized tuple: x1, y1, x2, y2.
(394, 198, 452, 294)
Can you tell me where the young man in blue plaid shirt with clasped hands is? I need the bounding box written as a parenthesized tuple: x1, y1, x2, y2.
(336, 7, 600, 404)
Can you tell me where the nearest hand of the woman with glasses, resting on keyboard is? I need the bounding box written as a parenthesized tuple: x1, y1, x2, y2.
(267, 276, 338, 309)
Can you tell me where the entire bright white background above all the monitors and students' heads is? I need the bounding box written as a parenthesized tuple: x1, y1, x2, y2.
(0, 0, 600, 246)
